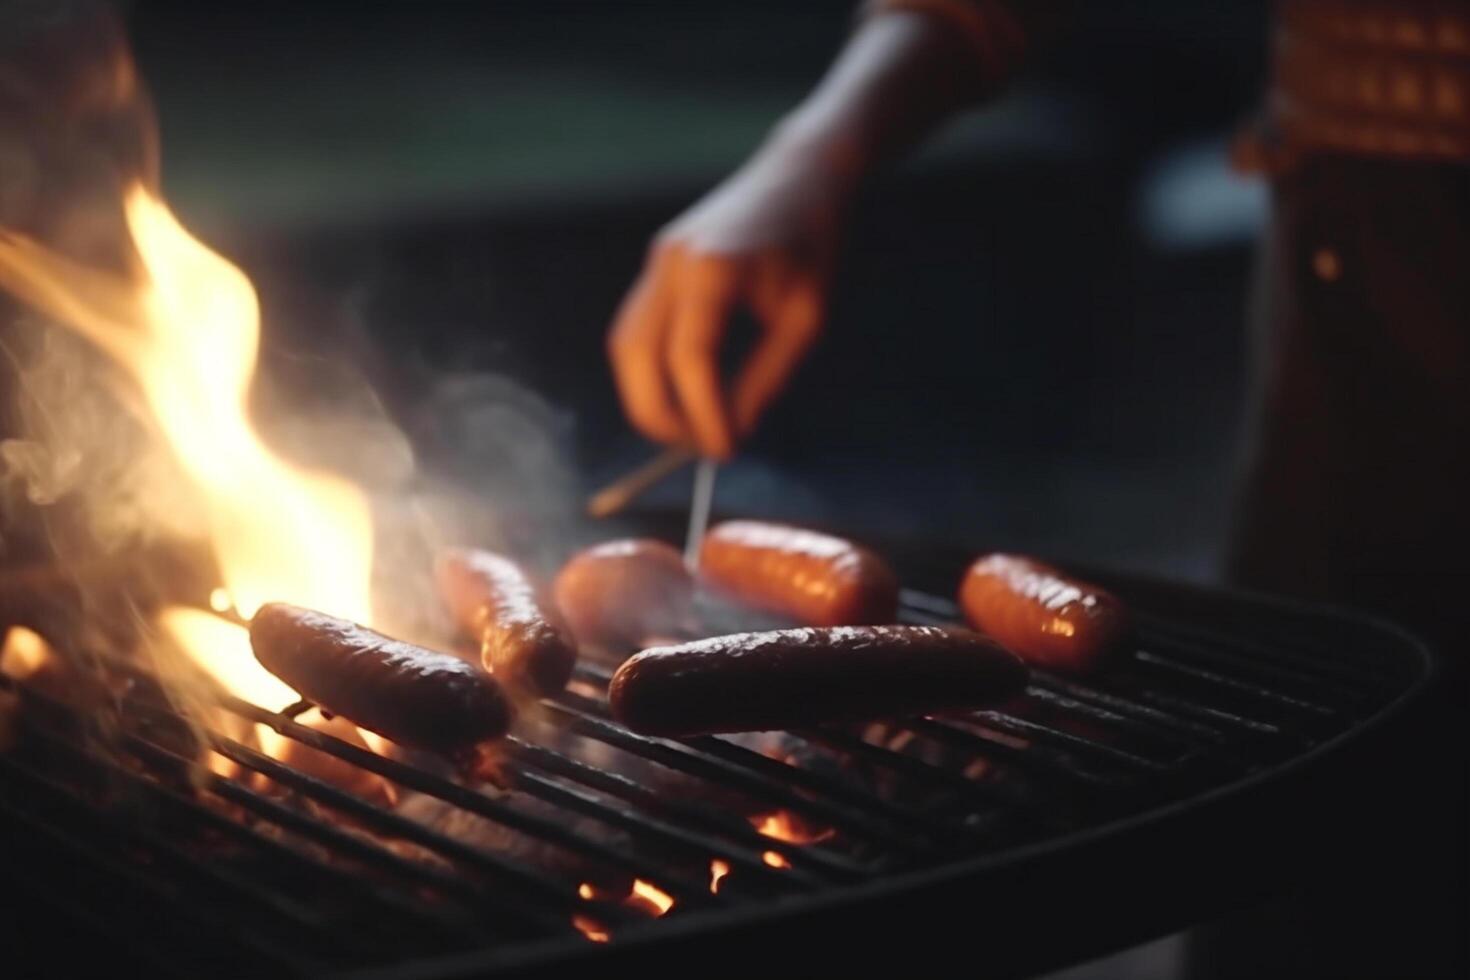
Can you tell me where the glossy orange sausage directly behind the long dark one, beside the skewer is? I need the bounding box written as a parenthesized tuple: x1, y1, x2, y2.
(700, 520, 898, 626)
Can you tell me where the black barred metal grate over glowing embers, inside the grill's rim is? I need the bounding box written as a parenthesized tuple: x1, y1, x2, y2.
(0, 570, 1427, 976)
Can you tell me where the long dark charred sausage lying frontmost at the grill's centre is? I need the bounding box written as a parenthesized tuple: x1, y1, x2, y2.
(607, 626, 1026, 735)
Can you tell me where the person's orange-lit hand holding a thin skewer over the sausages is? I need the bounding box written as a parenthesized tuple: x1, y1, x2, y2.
(607, 147, 850, 460)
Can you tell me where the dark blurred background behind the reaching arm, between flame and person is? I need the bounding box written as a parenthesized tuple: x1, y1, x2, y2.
(123, 0, 1266, 577)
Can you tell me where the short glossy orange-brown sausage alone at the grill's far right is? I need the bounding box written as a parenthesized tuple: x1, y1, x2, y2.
(960, 554, 1127, 673)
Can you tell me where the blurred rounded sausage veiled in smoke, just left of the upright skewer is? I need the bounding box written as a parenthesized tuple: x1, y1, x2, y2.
(553, 538, 694, 649)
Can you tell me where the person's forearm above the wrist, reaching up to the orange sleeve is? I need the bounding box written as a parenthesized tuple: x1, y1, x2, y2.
(763, 4, 1020, 182)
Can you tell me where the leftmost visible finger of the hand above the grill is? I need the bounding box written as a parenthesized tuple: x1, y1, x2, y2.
(607, 256, 689, 442)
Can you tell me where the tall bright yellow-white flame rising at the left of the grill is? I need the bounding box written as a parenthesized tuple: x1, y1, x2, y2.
(0, 184, 373, 719)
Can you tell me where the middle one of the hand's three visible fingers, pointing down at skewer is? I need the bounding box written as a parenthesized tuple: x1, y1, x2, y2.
(669, 257, 738, 460)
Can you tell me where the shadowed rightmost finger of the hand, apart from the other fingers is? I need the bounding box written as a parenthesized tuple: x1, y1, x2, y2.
(731, 270, 825, 438)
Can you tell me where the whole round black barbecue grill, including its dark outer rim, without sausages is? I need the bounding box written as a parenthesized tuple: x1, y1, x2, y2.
(0, 537, 1432, 979)
